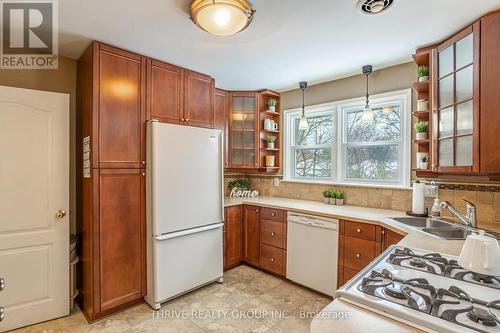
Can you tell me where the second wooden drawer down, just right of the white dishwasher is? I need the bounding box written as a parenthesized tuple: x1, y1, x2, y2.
(344, 237, 377, 270)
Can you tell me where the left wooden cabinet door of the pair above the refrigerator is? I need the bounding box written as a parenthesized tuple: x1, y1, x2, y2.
(147, 59, 184, 124)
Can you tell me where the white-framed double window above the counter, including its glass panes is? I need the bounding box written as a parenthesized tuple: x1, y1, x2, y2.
(284, 90, 411, 187)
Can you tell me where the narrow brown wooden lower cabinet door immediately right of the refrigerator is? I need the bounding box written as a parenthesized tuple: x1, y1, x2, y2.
(224, 205, 243, 269)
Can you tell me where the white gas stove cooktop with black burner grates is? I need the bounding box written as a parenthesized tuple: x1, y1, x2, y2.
(336, 246, 500, 333)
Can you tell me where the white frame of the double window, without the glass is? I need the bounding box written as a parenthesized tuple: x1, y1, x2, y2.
(283, 89, 412, 188)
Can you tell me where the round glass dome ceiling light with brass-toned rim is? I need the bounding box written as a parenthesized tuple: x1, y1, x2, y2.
(191, 0, 255, 36)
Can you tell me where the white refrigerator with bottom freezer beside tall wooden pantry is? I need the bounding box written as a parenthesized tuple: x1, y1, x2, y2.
(145, 121, 224, 309)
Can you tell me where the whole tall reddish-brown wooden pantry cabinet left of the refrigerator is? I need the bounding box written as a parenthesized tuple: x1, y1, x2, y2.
(78, 42, 146, 320)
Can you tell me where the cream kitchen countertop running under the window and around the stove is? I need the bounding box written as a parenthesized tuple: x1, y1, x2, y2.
(224, 196, 499, 333)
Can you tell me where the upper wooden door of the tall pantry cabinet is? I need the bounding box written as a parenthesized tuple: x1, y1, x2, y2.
(92, 43, 146, 168)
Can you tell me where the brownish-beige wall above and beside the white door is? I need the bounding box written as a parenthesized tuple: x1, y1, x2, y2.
(0, 57, 77, 232)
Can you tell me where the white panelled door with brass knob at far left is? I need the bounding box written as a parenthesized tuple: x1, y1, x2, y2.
(0, 86, 69, 332)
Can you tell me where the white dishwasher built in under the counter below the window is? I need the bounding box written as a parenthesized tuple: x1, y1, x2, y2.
(286, 212, 339, 296)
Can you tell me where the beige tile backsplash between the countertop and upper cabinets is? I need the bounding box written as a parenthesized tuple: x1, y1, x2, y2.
(225, 175, 500, 226)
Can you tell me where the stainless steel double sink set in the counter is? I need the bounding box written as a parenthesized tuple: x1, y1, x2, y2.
(392, 217, 500, 239)
